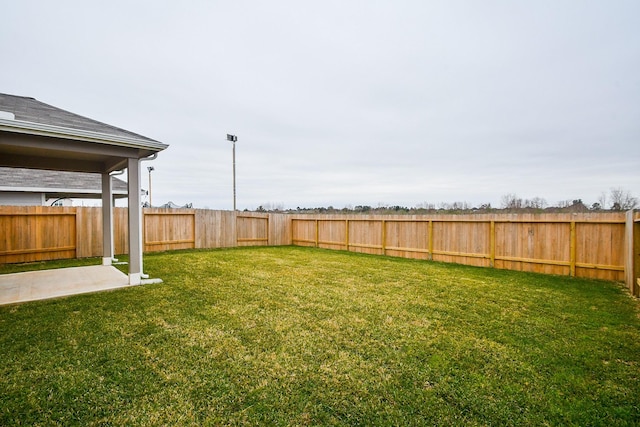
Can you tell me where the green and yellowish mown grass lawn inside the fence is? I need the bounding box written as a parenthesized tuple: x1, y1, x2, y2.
(0, 247, 640, 426)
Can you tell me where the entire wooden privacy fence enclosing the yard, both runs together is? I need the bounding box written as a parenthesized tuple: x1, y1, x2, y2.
(0, 206, 640, 295)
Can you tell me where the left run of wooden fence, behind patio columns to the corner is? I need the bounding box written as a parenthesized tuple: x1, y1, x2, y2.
(0, 206, 290, 264)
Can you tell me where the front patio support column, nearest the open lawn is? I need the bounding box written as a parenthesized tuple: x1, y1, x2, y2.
(127, 158, 142, 285)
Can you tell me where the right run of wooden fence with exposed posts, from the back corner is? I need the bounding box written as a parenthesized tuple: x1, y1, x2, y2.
(291, 213, 638, 286)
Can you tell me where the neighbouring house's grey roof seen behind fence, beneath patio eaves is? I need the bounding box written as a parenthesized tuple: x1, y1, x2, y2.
(0, 167, 127, 199)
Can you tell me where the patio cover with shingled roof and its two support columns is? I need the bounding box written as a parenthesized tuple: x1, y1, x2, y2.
(0, 94, 168, 300)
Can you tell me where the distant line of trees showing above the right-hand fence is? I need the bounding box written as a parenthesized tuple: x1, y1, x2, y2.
(255, 188, 639, 215)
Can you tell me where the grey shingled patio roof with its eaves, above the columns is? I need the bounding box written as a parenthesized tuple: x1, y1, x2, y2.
(0, 94, 168, 173)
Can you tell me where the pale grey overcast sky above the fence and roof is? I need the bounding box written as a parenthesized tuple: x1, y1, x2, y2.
(0, 0, 640, 209)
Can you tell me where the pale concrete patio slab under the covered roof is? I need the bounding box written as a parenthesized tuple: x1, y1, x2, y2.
(0, 265, 130, 305)
